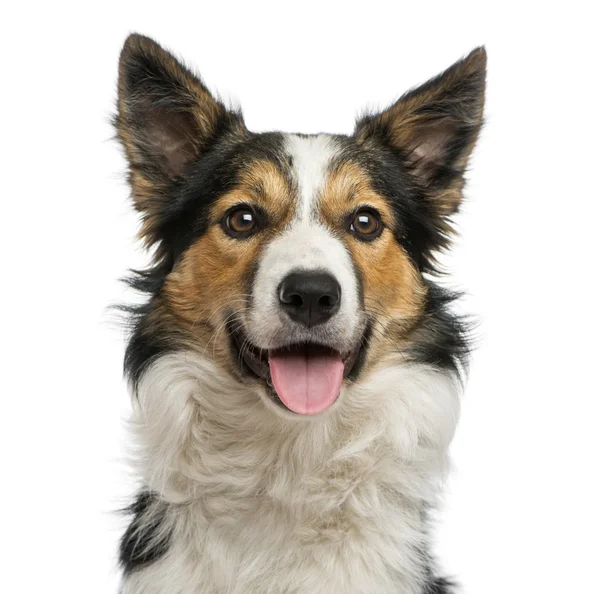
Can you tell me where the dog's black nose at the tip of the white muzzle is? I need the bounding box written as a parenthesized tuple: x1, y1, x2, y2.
(279, 272, 342, 328)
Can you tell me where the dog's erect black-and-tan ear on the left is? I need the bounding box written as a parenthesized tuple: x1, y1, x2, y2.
(115, 34, 245, 244)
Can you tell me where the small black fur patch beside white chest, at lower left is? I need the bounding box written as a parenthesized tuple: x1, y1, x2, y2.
(119, 491, 171, 574)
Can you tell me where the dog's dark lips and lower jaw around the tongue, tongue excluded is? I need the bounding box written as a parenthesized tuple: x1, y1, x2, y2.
(229, 324, 368, 419)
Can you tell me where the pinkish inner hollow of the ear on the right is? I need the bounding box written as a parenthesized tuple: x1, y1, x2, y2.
(407, 117, 456, 181)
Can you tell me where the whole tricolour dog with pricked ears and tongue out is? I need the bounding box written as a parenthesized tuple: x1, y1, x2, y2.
(115, 34, 486, 594)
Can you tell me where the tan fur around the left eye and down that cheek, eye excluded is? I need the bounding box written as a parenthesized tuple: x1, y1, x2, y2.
(163, 161, 294, 366)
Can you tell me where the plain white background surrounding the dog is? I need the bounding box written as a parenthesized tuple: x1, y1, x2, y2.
(0, 0, 600, 594)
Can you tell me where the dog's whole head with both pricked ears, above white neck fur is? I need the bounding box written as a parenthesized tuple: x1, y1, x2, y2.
(116, 36, 485, 417)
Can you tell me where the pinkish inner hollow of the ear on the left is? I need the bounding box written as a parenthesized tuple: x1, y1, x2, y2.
(148, 109, 196, 179)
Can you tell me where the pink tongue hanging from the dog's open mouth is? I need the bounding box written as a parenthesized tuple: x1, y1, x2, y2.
(269, 350, 344, 415)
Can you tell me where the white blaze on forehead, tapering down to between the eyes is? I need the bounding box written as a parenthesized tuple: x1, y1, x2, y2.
(285, 134, 337, 221)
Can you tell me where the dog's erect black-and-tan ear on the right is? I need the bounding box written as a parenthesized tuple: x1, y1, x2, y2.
(355, 47, 486, 216)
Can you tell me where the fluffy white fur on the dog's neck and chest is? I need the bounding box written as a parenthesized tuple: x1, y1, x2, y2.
(123, 352, 459, 594)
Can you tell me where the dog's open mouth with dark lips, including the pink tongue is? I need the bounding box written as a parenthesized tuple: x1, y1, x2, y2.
(230, 327, 366, 415)
